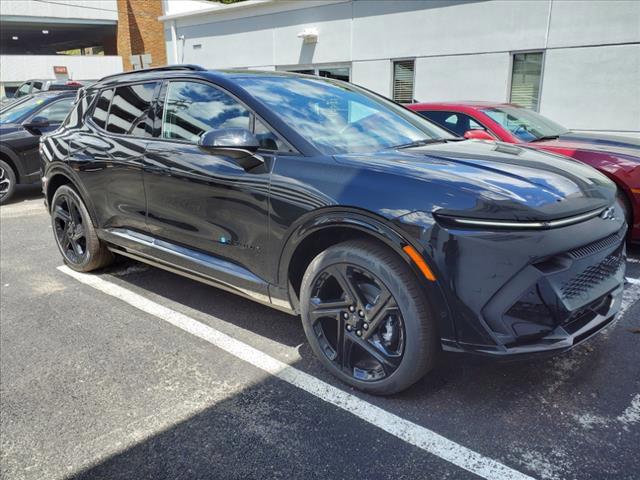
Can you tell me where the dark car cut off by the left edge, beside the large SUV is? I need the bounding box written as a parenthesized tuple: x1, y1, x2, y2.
(0, 91, 76, 204)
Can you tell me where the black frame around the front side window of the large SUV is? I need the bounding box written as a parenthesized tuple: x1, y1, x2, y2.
(153, 77, 300, 155)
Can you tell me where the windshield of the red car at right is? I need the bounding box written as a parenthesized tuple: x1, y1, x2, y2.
(482, 106, 569, 142)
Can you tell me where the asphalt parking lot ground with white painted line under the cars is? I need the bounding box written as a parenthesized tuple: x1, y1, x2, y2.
(0, 187, 640, 480)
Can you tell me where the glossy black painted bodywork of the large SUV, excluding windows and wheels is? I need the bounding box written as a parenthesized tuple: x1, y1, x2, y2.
(41, 71, 626, 355)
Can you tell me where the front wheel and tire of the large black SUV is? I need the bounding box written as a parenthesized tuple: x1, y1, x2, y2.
(300, 240, 440, 395)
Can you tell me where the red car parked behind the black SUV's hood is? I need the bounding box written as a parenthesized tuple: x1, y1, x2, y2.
(407, 102, 640, 240)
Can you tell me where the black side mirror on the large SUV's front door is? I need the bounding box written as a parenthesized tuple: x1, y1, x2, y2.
(198, 128, 264, 171)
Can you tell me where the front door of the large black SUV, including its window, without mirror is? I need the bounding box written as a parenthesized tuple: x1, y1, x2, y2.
(144, 80, 280, 295)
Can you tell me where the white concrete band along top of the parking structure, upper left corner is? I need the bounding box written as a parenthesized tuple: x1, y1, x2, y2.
(0, 0, 118, 21)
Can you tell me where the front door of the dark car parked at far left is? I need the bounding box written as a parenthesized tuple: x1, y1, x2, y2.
(16, 97, 74, 177)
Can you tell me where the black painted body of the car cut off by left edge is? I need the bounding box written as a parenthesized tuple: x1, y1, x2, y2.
(0, 92, 76, 183)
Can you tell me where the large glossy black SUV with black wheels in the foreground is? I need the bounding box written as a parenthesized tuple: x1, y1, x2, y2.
(41, 66, 627, 394)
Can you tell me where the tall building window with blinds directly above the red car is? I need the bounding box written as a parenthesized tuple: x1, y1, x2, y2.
(509, 52, 544, 111)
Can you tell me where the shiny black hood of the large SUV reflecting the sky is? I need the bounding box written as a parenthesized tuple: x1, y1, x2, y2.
(336, 140, 616, 221)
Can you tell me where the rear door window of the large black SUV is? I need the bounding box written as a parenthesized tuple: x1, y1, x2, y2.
(107, 82, 157, 137)
